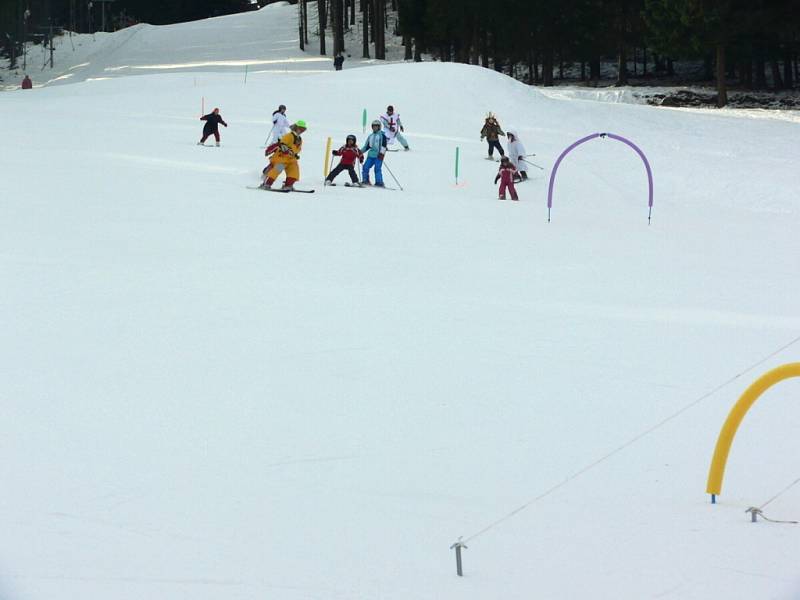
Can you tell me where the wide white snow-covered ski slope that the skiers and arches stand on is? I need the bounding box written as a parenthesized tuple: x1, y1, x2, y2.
(0, 6, 800, 600)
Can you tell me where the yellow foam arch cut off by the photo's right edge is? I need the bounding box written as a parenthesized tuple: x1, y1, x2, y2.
(706, 363, 800, 504)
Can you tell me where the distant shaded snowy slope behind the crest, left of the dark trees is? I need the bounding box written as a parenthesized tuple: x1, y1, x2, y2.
(0, 2, 401, 89)
